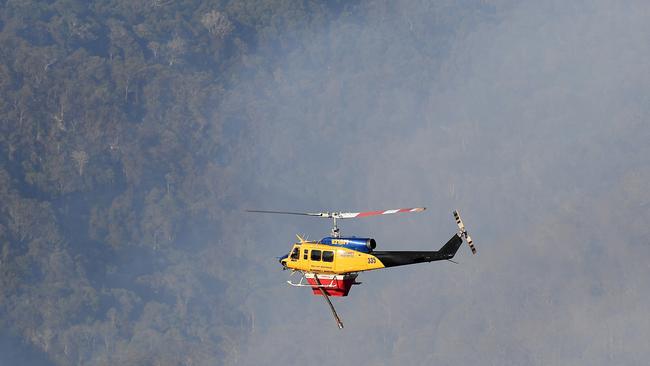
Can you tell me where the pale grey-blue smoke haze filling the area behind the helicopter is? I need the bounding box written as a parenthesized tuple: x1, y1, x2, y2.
(220, 1, 650, 365)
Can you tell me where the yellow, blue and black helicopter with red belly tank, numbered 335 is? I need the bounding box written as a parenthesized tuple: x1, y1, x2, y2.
(246, 207, 476, 329)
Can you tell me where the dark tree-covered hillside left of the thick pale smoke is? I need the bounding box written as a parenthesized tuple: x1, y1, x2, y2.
(0, 0, 351, 365)
